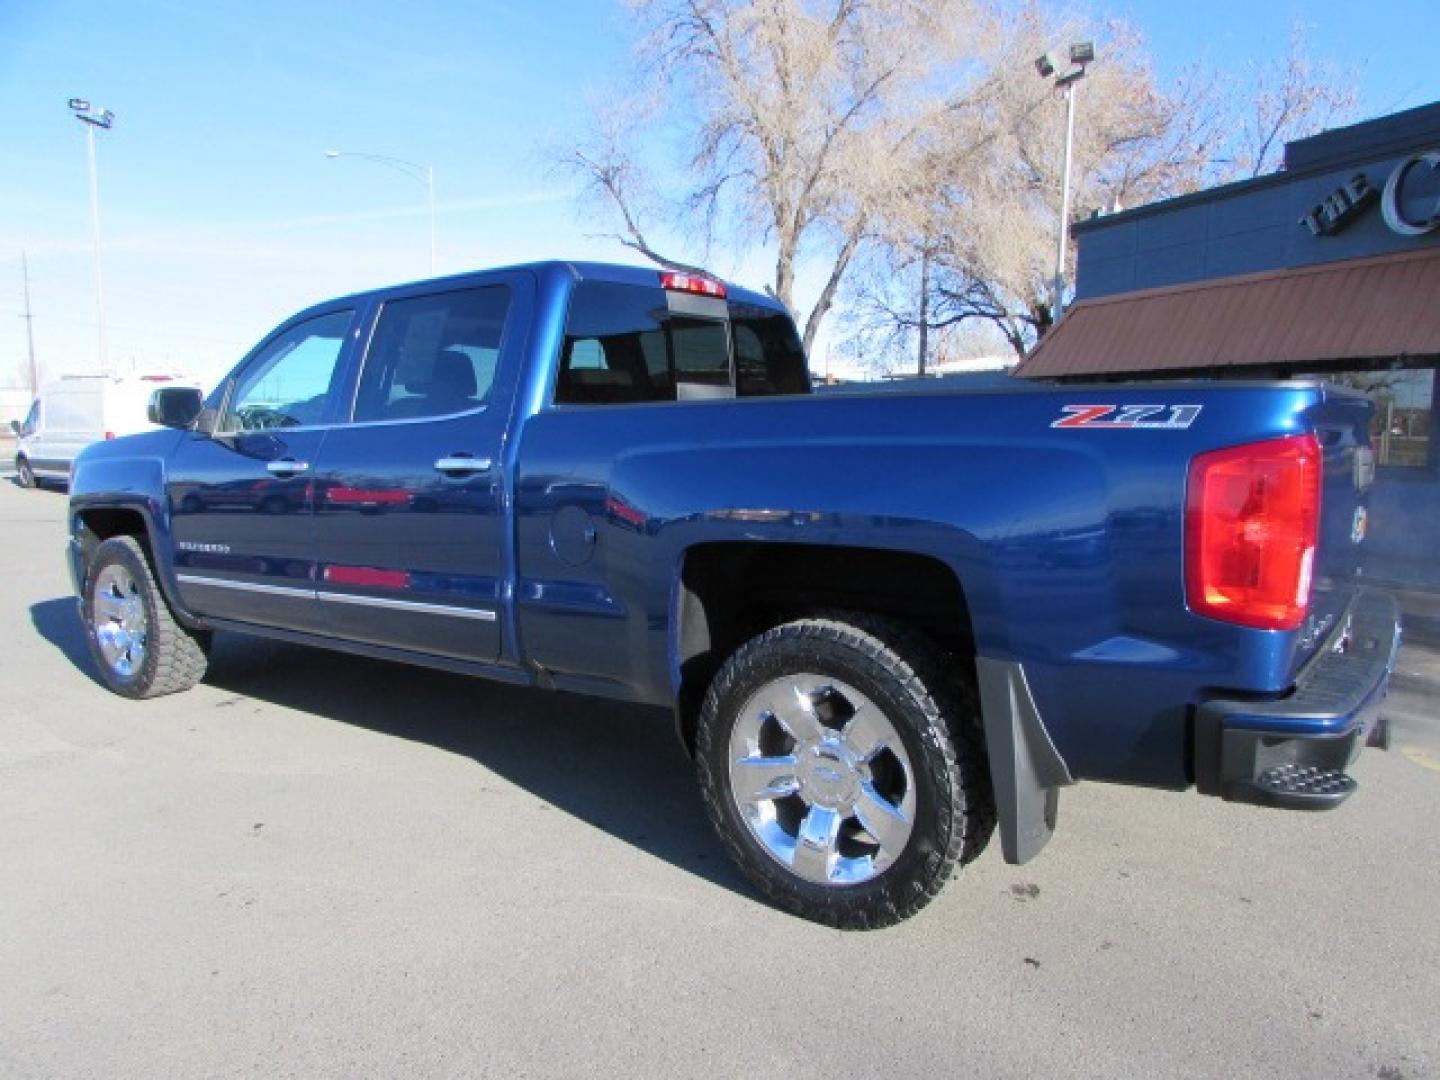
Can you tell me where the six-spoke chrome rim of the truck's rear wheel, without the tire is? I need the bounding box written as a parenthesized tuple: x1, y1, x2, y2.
(729, 674, 916, 886)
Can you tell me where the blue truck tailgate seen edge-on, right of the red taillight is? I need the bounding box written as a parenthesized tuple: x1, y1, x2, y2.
(1296, 386, 1375, 668)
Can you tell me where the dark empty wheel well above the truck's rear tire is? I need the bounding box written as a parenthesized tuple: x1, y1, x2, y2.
(677, 543, 975, 752)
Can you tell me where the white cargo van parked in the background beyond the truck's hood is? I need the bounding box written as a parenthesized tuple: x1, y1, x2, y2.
(10, 374, 199, 487)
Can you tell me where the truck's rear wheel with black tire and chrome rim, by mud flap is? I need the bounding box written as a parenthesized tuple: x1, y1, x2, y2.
(696, 615, 995, 929)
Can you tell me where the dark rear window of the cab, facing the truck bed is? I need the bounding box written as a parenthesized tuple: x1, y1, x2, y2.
(554, 281, 809, 405)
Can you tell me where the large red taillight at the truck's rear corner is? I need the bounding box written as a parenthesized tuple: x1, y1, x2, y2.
(1185, 435, 1320, 629)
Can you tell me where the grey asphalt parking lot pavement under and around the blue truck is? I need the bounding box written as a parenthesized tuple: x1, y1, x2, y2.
(0, 482, 1440, 1080)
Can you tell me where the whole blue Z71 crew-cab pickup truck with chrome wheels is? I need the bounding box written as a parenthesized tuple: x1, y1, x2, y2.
(69, 262, 1398, 927)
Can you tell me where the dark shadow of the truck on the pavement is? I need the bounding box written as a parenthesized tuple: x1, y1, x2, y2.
(30, 599, 757, 897)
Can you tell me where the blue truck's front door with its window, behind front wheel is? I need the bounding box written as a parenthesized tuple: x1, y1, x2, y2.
(166, 310, 356, 631)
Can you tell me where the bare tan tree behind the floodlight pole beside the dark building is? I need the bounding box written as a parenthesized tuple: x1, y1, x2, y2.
(848, 14, 1354, 364)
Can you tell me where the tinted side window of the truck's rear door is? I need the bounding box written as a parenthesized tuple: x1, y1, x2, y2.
(354, 285, 510, 422)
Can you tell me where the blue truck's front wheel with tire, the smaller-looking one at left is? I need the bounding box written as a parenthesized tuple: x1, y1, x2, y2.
(82, 536, 209, 697)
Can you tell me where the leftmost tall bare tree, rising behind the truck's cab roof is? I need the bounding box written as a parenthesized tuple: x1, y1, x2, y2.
(566, 0, 996, 347)
